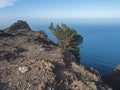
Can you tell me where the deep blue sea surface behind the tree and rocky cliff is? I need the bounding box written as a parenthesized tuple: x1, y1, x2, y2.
(0, 23, 120, 75)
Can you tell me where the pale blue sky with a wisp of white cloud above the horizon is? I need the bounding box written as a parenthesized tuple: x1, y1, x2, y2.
(0, 0, 120, 25)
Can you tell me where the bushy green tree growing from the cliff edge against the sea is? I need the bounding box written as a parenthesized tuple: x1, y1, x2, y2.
(49, 23, 83, 64)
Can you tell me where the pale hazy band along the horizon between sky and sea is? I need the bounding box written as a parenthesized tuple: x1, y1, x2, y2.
(0, 19, 120, 29)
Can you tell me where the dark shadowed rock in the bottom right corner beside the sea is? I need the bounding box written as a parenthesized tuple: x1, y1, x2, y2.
(103, 65, 120, 90)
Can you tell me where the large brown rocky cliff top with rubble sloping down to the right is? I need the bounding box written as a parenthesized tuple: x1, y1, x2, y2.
(0, 21, 111, 90)
